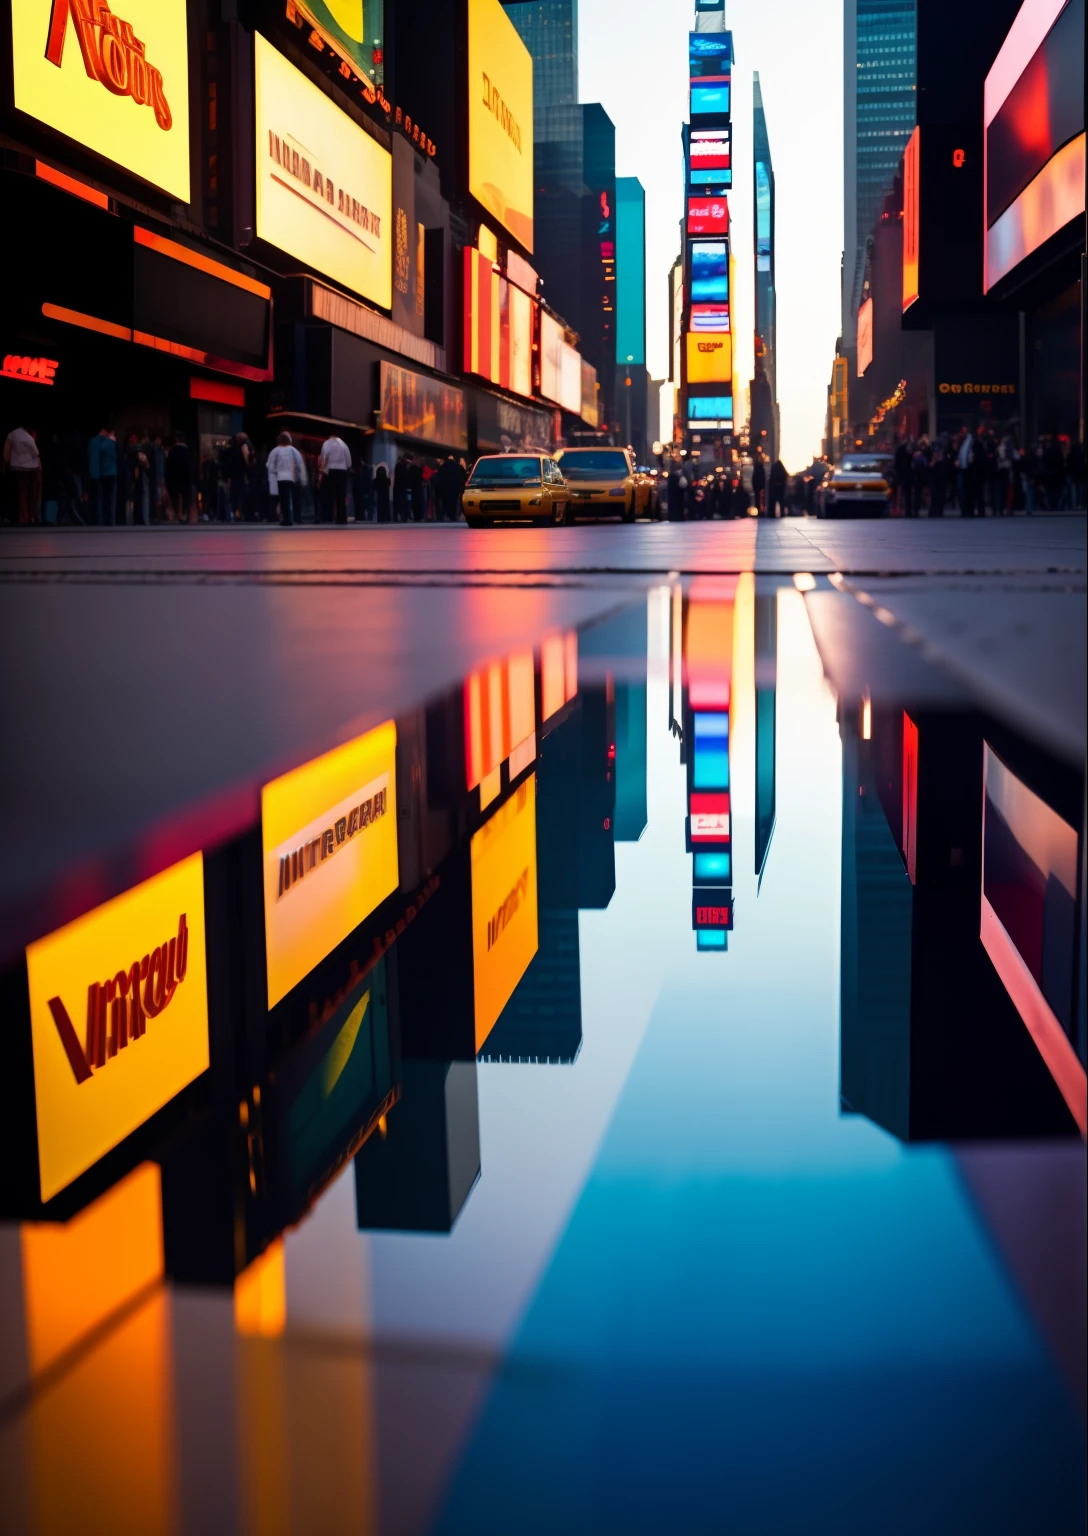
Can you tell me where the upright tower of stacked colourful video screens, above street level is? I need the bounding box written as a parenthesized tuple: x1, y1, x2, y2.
(684, 0, 733, 433)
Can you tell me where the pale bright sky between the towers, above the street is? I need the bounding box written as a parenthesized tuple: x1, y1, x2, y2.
(578, 0, 842, 470)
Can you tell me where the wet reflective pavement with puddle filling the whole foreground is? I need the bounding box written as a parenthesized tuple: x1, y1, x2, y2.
(0, 519, 1086, 1536)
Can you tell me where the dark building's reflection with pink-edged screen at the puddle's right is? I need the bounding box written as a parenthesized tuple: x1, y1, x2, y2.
(839, 702, 1085, 1141)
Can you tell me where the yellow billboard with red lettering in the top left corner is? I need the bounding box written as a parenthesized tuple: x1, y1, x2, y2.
(11, 0, 189, 203)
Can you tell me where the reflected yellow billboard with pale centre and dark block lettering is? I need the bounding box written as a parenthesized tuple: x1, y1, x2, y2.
(261, 720, 400, 1008)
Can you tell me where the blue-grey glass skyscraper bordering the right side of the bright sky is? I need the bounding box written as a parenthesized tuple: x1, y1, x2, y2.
(842, 0, 915, 355)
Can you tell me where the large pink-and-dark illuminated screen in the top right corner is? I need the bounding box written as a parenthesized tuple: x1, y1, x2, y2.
(984, 0, 1085, 292)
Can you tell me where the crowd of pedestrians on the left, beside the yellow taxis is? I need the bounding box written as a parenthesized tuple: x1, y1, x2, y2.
(0, 421, 467, 527)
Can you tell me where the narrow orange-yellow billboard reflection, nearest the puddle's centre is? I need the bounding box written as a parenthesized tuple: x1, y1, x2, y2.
(472, 774, 538, 1051)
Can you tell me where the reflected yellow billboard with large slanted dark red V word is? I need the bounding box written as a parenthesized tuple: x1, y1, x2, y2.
(26, 854, 209, 1201)
